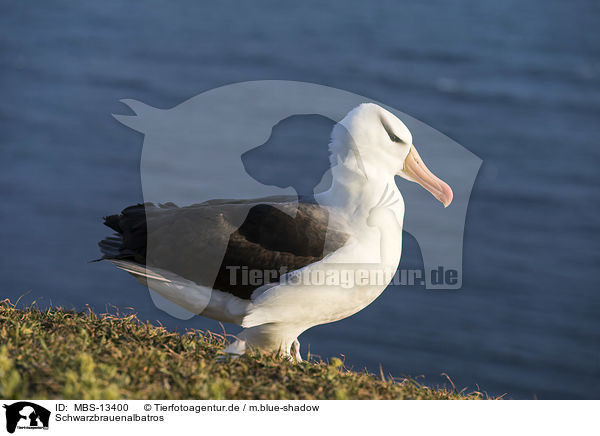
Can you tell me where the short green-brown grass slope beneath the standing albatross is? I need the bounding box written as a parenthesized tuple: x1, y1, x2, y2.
(0, 300, 486, 400)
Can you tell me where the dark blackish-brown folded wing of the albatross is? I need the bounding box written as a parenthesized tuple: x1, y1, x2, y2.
(99, 197, 348, 299)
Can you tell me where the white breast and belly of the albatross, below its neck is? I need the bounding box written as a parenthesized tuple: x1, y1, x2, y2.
(242, 193, 404, 329)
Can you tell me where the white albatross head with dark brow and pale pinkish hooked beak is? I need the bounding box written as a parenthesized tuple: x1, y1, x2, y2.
(330, 103, 453, 207)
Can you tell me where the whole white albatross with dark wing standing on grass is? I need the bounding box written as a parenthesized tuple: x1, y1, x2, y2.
(99, 103, 452, 360)
